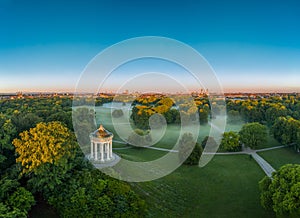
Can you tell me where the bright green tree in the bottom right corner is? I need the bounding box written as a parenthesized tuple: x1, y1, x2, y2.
(259, 164, 300, 217)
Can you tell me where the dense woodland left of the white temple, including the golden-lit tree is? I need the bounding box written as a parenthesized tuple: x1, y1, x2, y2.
(0, 97, 146, 217)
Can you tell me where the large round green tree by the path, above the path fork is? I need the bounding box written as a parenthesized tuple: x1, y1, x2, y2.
(239, 122, 267, 149)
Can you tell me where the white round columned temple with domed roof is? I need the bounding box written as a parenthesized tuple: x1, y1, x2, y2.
(89, 125, 115, 163)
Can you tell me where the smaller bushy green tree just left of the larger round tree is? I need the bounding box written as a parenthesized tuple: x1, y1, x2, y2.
(220, 131, 242, 152)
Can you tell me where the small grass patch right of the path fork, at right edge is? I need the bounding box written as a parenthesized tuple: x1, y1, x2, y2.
(258, 147, 300, 170)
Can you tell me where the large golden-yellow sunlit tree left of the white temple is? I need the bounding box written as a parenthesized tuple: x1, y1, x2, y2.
(13, 122, 74, 173)
